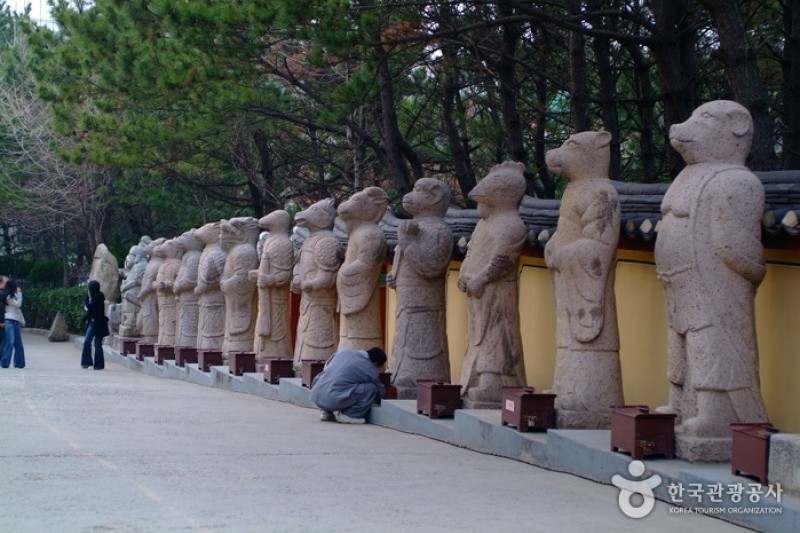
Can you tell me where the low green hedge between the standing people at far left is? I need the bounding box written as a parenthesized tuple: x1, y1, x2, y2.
(22, 286, 86, 334)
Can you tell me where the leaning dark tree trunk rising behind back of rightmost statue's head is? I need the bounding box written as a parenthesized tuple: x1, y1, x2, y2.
(699, 0, 775, 170)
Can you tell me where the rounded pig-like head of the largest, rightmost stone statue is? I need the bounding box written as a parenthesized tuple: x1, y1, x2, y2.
(669, 100, 753, 165)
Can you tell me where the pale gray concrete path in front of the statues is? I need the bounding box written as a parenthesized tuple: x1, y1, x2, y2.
(0, 333, 740, 533)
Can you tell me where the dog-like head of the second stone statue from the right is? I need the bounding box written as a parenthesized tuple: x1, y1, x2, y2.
(545, 131, 611, 181)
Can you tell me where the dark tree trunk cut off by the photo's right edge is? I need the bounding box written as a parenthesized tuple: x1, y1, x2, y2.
(782, 0, 800, 170)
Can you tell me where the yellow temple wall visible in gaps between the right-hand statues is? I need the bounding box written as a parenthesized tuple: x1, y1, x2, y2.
(386, 245, 800, 433)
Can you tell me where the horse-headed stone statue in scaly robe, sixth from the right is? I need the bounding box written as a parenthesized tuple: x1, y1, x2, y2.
(291, 198, 342, 371)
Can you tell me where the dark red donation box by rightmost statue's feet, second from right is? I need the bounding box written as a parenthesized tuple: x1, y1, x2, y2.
(611, 405, 675, 459)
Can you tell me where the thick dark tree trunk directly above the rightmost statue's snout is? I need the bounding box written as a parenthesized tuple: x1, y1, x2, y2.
(650, 0, 698, 178)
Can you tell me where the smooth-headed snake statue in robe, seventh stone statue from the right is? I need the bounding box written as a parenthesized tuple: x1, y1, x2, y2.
(250, 209, 294, 364)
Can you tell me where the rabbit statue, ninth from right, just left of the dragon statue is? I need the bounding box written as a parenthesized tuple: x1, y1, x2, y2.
(194, 222, 225, 350)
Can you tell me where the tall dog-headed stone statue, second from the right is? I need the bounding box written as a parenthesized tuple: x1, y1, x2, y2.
(544, 131, 624, 429)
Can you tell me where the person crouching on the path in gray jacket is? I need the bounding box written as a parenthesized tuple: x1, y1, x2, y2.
(311, 348, 386, 424)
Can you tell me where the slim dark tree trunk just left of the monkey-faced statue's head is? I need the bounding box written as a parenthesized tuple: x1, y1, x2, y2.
(374, 45, 411, 196)
